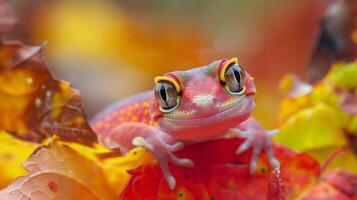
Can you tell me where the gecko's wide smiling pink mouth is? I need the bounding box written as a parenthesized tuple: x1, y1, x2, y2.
(158, 95, 255, 131)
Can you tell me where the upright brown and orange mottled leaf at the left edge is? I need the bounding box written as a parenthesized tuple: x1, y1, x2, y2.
(0, 44, 96, 145)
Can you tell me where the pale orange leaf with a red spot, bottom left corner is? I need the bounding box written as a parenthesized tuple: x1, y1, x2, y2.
(0, 141, 114, 200)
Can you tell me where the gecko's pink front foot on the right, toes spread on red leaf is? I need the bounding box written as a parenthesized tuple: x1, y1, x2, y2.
(230, 117, 280, 174)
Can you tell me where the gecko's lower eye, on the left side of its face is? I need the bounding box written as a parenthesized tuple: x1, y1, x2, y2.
(154, 80, 180, 113)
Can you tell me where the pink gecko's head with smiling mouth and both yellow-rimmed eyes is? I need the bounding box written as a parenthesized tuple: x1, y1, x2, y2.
(150, 58, 255, 141)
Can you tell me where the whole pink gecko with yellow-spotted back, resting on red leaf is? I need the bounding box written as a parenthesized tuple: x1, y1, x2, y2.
(92, 58, 279, 189)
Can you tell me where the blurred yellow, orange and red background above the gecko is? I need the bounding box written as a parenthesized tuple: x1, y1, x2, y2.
(8, 0, 331, 128)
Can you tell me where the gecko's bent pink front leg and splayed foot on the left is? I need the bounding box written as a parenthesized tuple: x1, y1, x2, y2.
(99, 122, 194, 190)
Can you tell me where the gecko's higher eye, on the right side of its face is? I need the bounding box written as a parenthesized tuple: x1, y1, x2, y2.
(220, 60, 245, 95)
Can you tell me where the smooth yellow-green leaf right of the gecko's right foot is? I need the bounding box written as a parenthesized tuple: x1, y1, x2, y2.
(275, 103, 347, 151)
